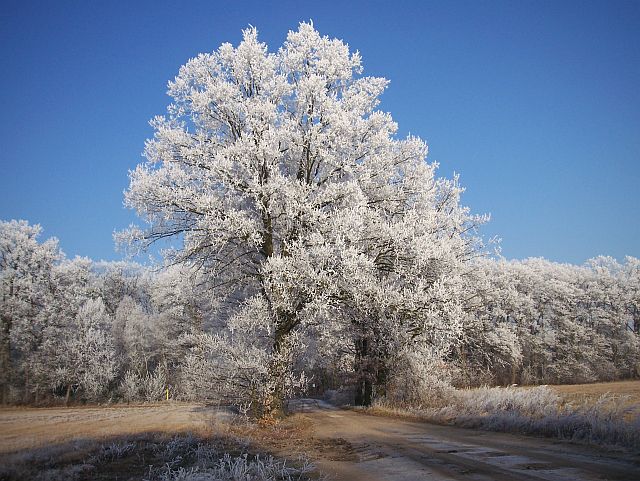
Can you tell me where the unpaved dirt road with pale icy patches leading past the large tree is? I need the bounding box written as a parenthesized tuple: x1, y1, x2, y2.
(297, 400, 640, 481)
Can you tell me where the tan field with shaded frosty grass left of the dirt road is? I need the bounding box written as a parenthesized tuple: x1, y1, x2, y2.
(0, 402, 313, 481)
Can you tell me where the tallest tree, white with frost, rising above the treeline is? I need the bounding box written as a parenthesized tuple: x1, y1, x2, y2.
(121, 23, 477, 413)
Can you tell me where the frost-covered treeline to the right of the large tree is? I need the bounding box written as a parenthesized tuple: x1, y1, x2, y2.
(452, 257, 640, 385)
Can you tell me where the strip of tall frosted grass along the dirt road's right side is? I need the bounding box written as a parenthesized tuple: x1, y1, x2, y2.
(370, 386, 640, 452)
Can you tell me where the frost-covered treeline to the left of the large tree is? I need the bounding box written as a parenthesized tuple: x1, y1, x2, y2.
(0, 221, 201, 403)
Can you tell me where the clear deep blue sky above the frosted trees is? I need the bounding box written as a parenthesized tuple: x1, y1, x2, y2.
(0, 0, 640, 263)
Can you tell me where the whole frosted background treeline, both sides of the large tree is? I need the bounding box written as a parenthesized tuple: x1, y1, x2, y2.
(0, 221, 640, 409)
